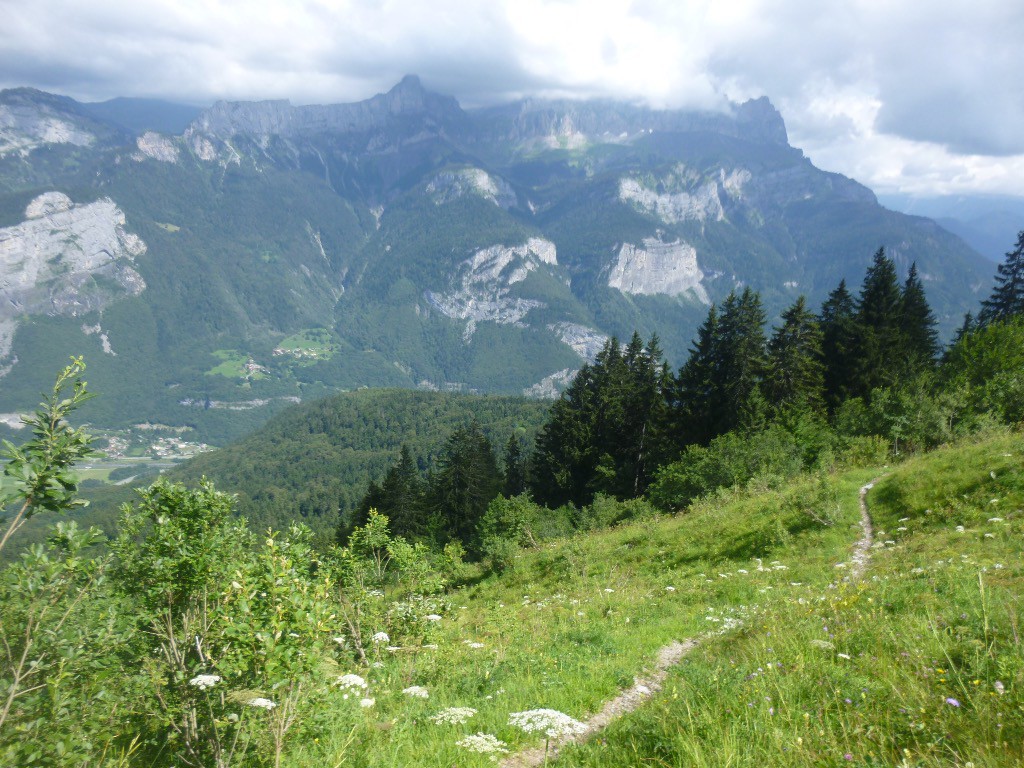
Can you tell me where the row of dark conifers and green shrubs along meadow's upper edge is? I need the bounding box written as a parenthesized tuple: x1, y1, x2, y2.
(346, 237, 1024, 553)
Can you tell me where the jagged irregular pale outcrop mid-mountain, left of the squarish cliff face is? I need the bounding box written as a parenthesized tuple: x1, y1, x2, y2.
(426, 238, 558, 341)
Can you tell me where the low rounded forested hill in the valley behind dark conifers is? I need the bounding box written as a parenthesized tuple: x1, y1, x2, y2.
(12, 389, 549, 541)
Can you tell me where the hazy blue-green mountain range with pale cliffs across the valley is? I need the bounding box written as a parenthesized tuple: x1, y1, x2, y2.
(0, 76, 993, 442)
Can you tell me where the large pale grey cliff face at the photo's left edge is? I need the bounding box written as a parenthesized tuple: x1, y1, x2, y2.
(0, 191, 145, 368)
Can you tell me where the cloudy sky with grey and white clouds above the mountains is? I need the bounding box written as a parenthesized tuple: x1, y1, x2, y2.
(0, 0, 1024, 196)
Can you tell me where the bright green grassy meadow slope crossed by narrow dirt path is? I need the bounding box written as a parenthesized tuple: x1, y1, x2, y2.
(268, 435, 1024, 768)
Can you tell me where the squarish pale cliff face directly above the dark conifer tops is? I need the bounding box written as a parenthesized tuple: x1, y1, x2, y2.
(608, 238, 711, 304)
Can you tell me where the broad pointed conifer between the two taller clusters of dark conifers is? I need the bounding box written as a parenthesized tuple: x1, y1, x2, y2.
(766, 296, 824, 411)
